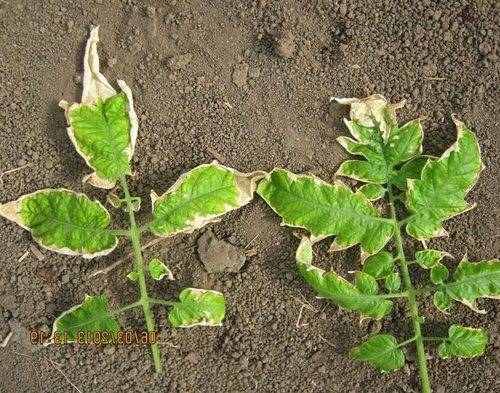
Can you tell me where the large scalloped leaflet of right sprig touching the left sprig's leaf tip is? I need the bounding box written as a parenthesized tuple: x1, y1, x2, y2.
(257, 169, 394, 254)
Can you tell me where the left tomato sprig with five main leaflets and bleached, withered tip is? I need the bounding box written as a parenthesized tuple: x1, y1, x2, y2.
(0, 28, 262, 373)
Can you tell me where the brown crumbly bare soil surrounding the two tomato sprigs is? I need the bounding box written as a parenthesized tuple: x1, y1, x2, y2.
(0, 0, 500, 393)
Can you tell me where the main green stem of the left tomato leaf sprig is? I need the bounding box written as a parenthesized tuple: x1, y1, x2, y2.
(120, 176, 162, 374)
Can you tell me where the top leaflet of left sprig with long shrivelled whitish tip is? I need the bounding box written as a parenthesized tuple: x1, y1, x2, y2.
(59, 28, 138, 189)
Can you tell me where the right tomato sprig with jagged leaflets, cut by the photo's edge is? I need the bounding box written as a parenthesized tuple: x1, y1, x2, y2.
(257, 95, 500, 392)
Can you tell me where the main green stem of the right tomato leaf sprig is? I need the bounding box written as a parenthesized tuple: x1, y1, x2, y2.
(387, 184, 431, 393)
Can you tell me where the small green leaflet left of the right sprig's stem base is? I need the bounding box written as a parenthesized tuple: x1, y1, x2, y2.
(351, 334, 405, 372)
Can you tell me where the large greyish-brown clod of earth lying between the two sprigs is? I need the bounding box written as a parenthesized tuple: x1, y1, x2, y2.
(198, 230, 246, 273)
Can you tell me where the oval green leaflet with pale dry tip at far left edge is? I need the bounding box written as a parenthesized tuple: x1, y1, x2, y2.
(0, 189, 118, 258)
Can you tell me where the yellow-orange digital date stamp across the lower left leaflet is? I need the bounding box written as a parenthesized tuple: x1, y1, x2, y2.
(28, 330, 156, 345)
